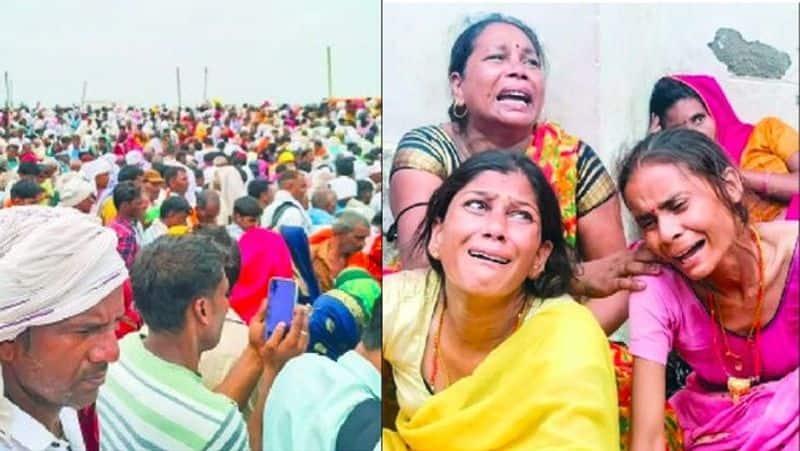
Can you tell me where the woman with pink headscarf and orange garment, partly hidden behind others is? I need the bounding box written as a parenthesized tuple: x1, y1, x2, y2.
(650, 75, 800, 222)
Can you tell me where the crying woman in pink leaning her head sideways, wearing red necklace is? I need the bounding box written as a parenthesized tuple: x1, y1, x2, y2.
(618, 129, 800, 451)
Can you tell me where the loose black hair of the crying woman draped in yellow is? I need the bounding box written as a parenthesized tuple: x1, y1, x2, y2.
(414, 150, 574, 298)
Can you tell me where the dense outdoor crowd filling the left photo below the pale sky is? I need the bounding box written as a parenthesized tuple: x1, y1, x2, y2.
(0, 98, 382, 450)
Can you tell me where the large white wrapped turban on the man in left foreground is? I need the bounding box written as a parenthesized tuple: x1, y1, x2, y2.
(0, 206, 128, 341)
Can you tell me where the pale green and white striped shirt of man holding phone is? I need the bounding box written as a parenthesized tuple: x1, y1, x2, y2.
(97, 334, 250, 451)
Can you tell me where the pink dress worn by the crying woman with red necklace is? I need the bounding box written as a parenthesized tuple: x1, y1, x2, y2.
(630, 245, 800, 451)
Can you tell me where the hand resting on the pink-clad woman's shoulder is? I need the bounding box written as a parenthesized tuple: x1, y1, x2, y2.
(570, 246, 661, 298)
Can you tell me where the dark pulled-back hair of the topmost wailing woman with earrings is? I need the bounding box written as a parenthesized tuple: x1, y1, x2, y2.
(447, 13, 545, 129)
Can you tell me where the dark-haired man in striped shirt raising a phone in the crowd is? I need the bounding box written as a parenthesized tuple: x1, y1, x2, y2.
(98, 235, 308, 450)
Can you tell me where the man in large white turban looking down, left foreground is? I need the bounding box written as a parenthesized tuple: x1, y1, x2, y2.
(0, 206, 128, 450)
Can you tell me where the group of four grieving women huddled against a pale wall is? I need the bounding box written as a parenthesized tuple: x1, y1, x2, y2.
(382, 13, 800, 451)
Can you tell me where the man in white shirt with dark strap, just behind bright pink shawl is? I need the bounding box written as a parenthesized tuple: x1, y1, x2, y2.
(261, 170, 311, 235)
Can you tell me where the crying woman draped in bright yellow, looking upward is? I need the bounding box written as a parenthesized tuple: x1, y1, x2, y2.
(383, 151, 619, 450)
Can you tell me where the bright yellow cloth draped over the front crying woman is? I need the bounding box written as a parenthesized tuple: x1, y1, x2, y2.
(383, 270, 619, 451)
